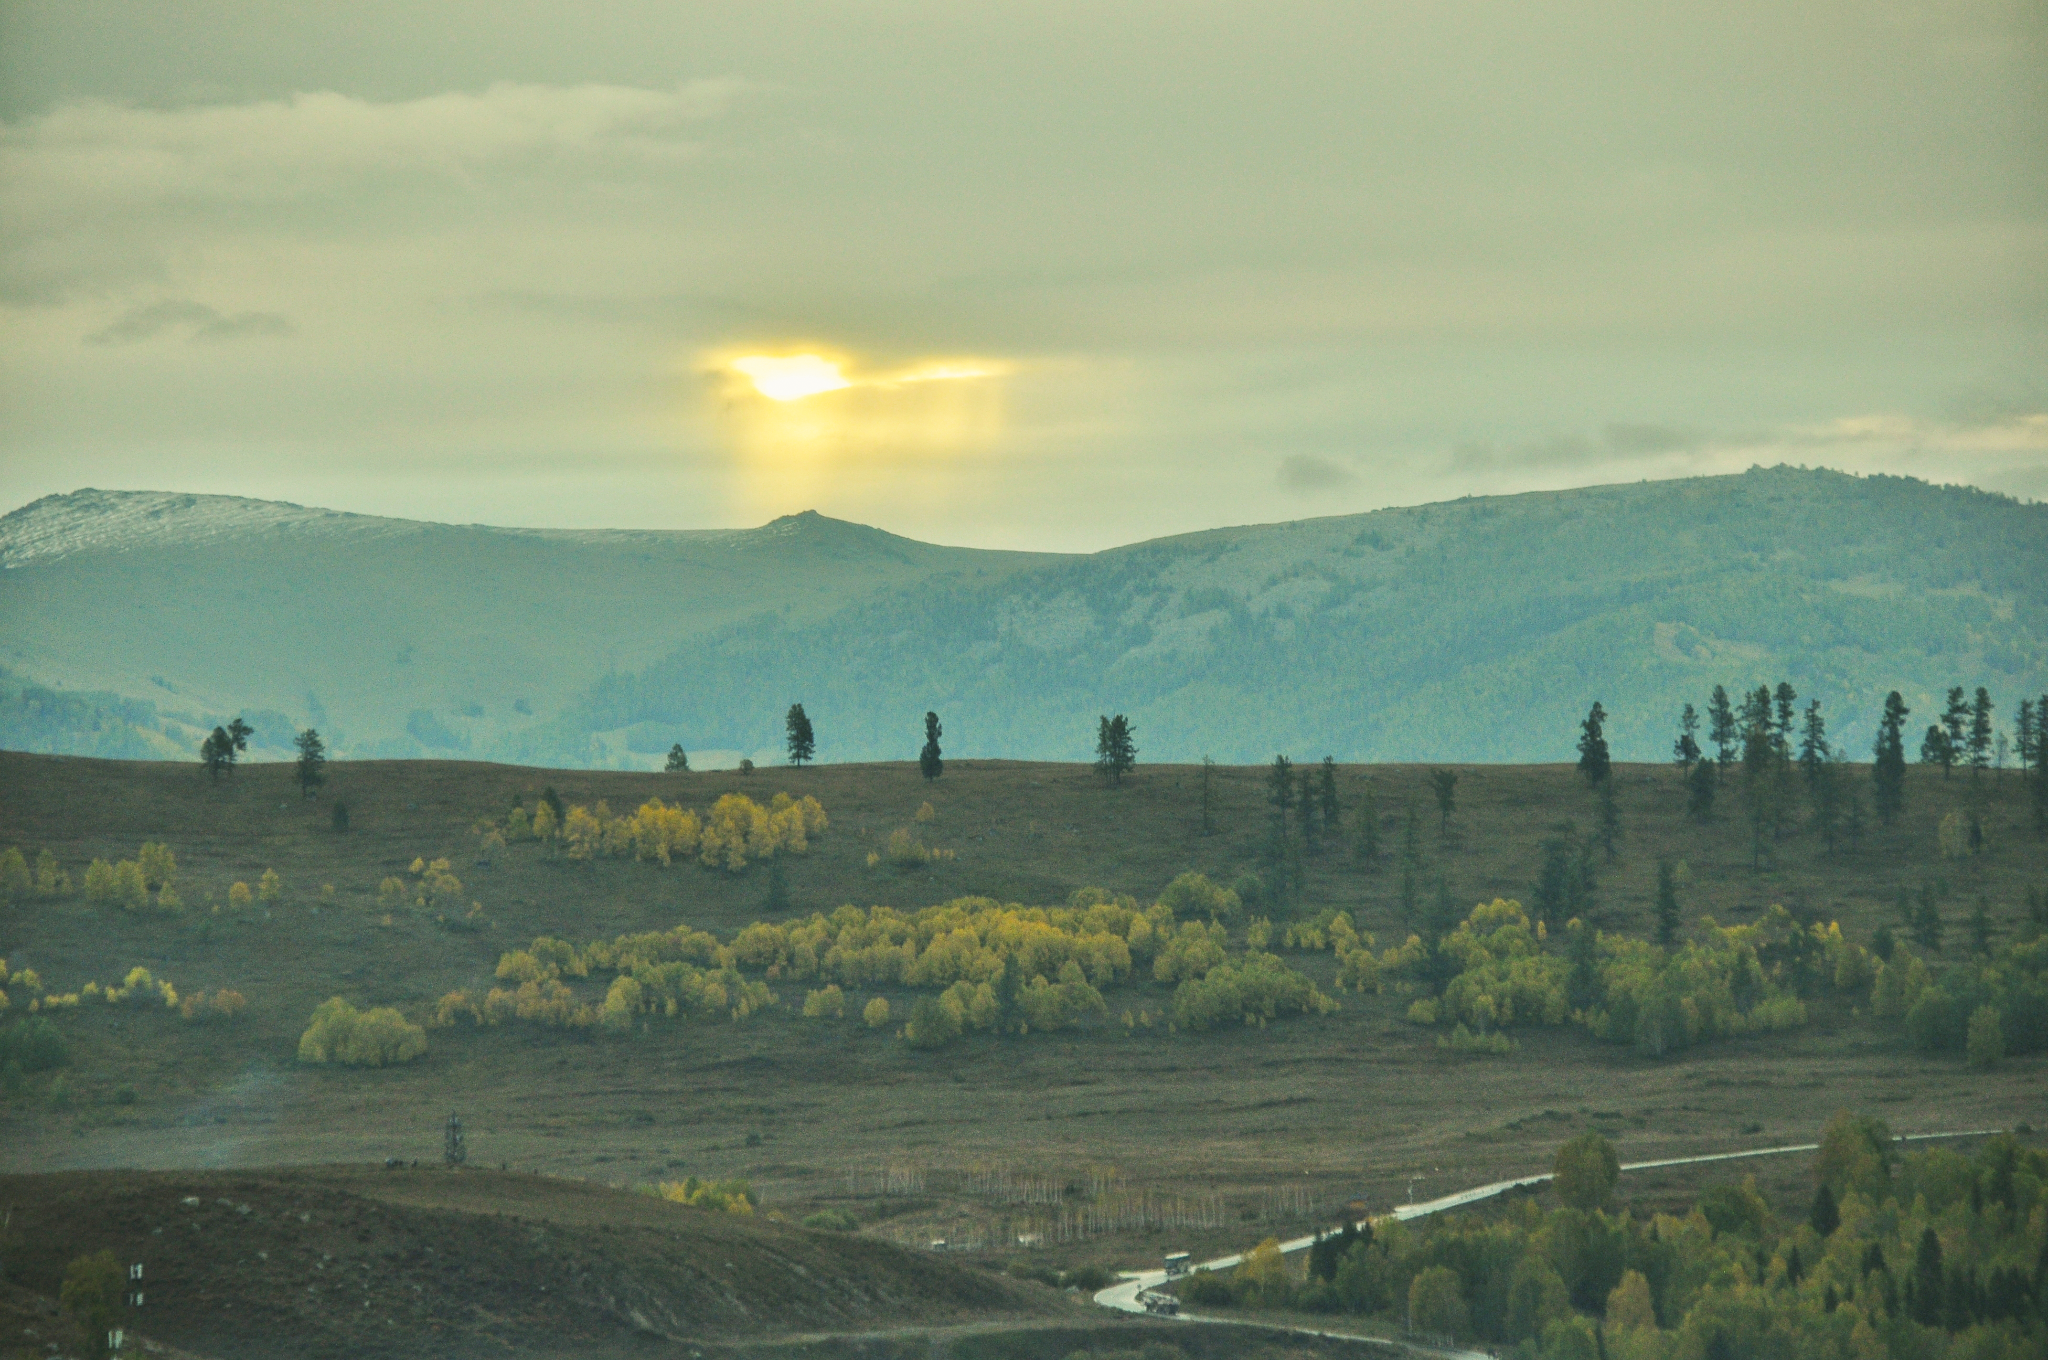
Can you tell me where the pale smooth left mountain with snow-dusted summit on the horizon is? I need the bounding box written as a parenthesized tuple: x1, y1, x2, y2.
(0, 492, 1042, 766)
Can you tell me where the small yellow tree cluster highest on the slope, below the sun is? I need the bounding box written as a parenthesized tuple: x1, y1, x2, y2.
(483, 789, 831, 873)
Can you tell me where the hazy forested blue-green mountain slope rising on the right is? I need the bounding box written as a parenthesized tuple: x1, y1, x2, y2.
(557, 467, 2048, 762)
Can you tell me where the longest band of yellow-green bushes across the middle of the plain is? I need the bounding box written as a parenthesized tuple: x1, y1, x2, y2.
(434, 875, 1335, 1047)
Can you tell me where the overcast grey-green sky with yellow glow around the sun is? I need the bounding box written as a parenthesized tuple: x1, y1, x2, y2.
(0, 0, 2048, 549)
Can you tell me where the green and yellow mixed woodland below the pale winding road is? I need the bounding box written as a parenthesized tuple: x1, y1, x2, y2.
(1186, 1112, 2048, 1360)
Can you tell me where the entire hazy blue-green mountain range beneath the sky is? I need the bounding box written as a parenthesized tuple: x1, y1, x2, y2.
(0, 467, 2048, 768)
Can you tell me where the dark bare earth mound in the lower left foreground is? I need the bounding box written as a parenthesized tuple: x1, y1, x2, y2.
(0, 1167, 1081, 1360)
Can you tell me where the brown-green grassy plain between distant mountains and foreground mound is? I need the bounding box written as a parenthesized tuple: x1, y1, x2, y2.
(0, 756, 2048, 1294)
